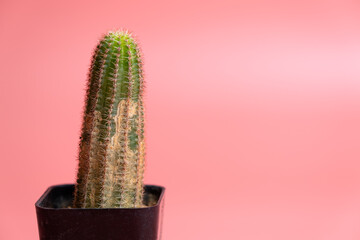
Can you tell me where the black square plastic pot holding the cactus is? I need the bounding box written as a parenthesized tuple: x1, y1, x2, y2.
(35, 184, 165, 240)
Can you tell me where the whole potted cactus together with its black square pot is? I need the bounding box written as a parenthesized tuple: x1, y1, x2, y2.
(35, 31, 165, 240)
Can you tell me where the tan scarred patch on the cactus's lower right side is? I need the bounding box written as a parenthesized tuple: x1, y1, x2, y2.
(102, 100, 144, 207)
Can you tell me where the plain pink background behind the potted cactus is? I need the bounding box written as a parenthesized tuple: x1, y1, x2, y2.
(0, 0, 360, 240)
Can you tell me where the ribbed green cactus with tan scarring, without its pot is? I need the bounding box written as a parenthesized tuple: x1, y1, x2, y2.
(73, 31, 145, 208)
